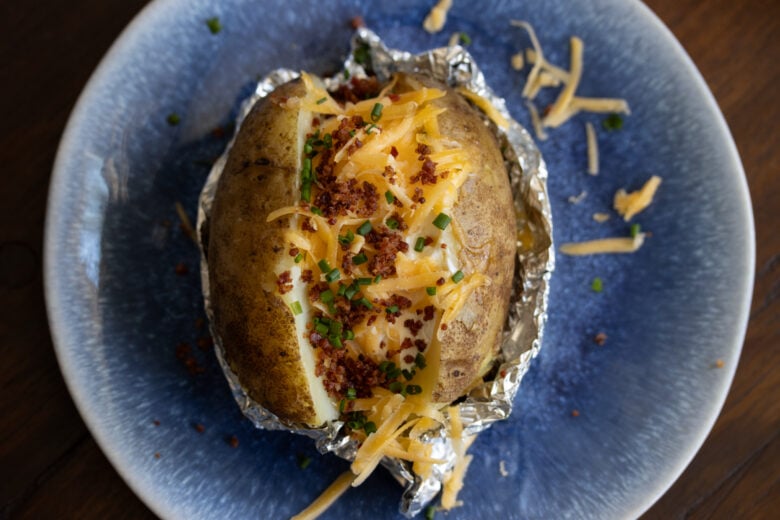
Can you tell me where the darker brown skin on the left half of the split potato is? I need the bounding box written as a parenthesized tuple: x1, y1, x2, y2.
(207, 81, 317, 426)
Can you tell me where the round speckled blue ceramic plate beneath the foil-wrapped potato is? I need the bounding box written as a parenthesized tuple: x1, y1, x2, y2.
(45, 0, 754, 519)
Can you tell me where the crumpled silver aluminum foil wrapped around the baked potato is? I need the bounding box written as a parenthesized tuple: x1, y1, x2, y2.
(197, 28, 555, 517)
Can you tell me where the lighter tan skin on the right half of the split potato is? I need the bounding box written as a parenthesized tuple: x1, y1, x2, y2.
(399, 76, 517, 402)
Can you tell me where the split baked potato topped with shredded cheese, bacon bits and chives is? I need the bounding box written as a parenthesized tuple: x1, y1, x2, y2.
(205, 73, 517, 439)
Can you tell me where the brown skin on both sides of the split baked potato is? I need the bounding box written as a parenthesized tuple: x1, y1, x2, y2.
(207, 75, 516, 427)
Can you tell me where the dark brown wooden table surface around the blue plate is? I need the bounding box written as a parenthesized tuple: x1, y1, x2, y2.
(0, 0, 780, 519)
